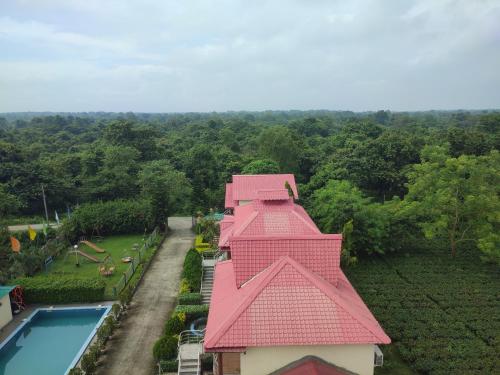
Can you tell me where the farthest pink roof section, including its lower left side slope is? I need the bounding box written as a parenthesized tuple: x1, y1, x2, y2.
(225, 174, 299, 208)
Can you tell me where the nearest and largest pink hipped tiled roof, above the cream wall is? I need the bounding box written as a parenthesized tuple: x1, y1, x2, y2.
(205, 257, 390, 351)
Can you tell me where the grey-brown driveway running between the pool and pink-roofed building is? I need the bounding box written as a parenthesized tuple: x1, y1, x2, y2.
(98, 217, 194, 375)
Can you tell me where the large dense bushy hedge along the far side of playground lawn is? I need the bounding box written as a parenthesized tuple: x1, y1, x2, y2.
(61, 200, 154, 241)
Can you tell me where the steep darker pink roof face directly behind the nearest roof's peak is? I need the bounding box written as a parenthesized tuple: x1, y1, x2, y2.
(229, 234, 342, 286)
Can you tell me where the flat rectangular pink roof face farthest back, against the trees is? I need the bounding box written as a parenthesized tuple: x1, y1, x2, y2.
(232, 174, 299, 201)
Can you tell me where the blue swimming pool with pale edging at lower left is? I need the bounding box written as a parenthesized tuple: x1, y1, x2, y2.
(0, 306, 111, 375)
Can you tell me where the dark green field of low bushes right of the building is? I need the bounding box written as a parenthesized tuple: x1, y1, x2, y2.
(346, 250, 500, 374)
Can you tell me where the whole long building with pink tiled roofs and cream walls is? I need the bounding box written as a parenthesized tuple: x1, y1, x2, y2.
(203, 175, 390, 375)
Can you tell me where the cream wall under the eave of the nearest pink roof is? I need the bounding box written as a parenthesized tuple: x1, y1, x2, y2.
(240, 345, 373, 375)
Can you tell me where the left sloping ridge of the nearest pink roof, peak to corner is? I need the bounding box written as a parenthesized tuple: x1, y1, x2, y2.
(205, 256, 291, 346)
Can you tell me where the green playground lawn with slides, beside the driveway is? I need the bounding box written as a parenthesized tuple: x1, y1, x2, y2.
(50, 234, 143, 297)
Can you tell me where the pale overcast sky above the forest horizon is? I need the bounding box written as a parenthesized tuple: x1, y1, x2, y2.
(0, 0, 500, 112)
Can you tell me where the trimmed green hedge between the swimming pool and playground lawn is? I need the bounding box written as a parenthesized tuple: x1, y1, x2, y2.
(13, 275, 106, 303)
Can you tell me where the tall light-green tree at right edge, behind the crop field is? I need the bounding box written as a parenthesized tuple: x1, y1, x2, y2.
(404, 146, 500, 263)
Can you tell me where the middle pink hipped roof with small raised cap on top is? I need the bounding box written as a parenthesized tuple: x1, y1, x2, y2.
(219, 198, 321, 248)
